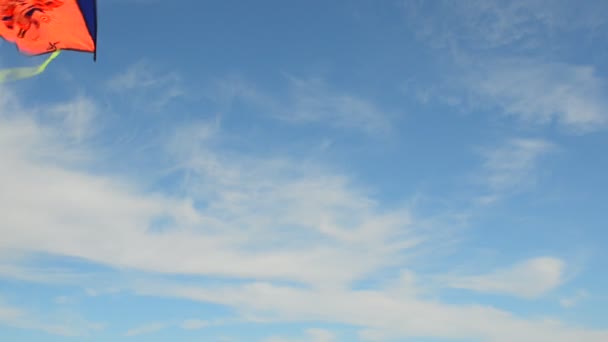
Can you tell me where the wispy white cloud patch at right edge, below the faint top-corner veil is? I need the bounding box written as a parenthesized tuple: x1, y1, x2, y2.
(476, 60, 608, 133)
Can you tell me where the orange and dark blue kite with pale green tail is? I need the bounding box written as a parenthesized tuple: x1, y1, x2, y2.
(0, 0, 97, 83)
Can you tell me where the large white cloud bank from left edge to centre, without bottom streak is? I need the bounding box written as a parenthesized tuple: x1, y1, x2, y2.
(0, 85, 421, 286)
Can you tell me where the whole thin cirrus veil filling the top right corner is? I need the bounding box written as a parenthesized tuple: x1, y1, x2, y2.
(403, 0, 608, 134)
